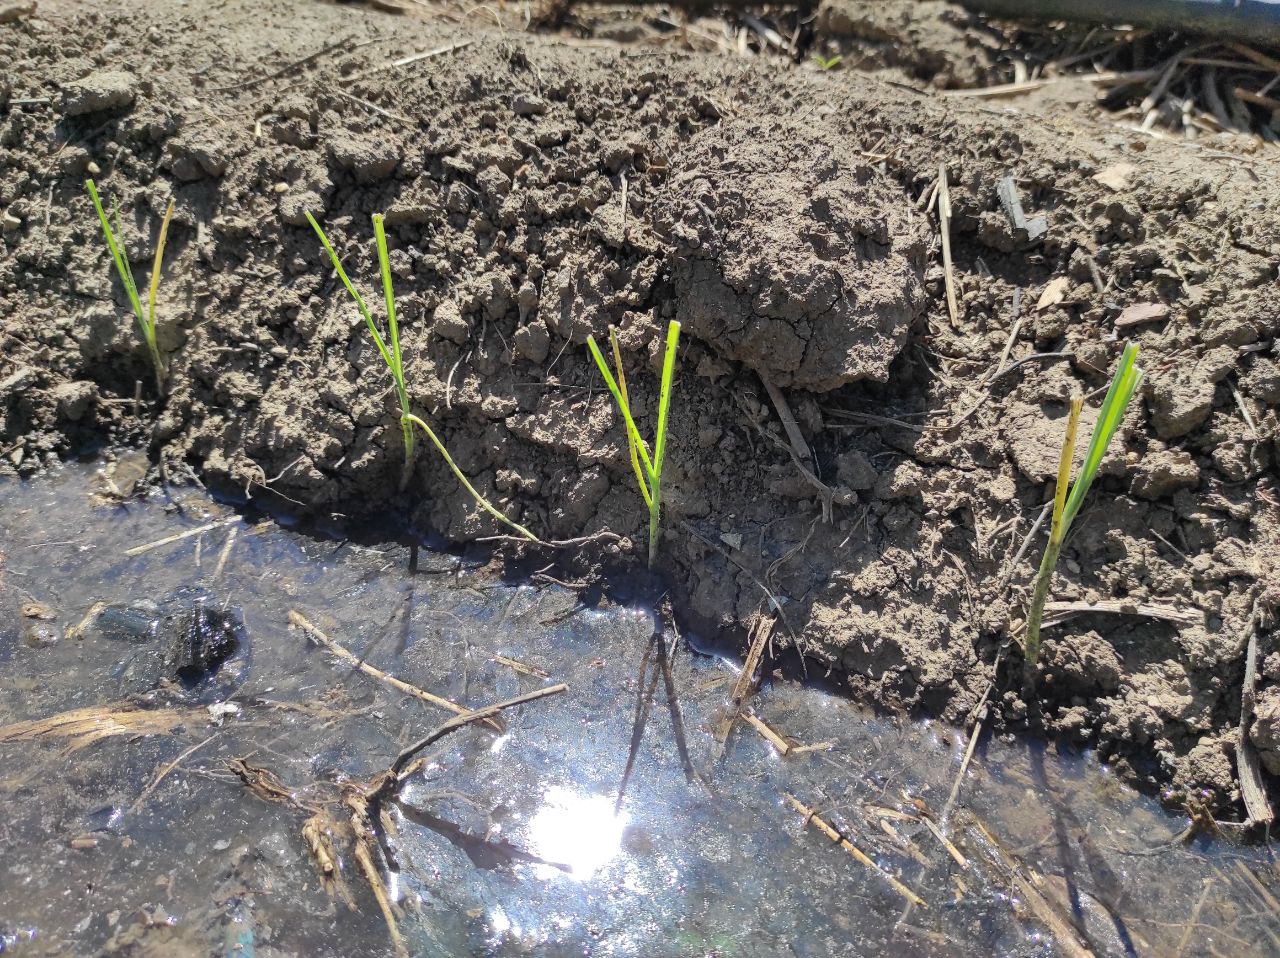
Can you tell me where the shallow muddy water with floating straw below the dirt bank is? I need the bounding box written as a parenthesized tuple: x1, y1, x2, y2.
(0, 465, 1280, 955)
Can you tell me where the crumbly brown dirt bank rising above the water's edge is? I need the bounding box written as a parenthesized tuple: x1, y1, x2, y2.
(0, 0, 1280, 807)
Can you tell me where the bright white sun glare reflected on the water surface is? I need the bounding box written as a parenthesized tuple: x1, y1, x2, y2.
(529, 785, 630, 881)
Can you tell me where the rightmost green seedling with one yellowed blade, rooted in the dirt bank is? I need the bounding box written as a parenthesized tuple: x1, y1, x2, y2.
(1023, 343, 1142, 701)
